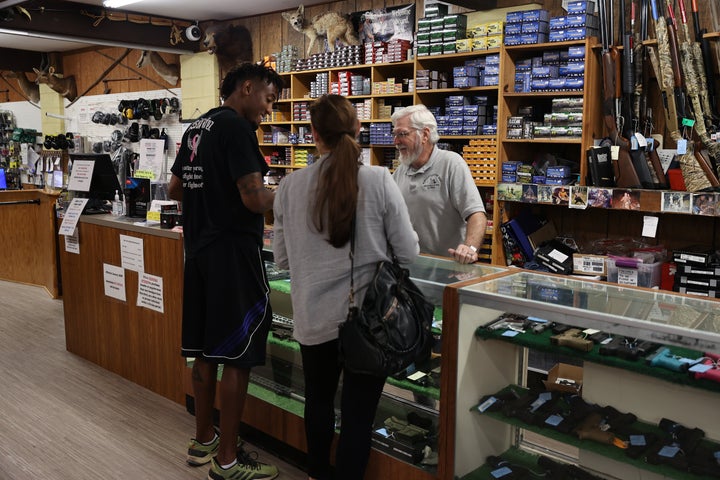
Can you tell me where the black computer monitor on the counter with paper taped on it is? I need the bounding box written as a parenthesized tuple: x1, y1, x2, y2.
(70, 153, 123, 214)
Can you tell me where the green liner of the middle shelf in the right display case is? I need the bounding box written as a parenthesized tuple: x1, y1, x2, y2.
(468, 385, 720, 480)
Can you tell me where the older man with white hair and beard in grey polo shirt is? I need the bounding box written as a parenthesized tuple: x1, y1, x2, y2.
(391, 105, 487, 263)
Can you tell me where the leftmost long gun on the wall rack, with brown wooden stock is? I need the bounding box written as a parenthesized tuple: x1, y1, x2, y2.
(598, 0, 642, 188)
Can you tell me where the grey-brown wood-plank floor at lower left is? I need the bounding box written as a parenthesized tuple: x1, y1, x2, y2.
(0, 281, 307, 480)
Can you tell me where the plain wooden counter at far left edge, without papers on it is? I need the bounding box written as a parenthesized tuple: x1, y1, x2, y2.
(0, 190, 60, 298)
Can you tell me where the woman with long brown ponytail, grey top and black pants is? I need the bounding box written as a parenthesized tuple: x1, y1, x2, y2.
(273, 95, 419, 480)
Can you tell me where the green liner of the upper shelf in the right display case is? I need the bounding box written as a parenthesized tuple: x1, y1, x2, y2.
(475, 327, 720, 392)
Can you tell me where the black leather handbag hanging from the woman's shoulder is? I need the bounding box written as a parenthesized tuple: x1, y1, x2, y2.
(339, 222, 434, 377)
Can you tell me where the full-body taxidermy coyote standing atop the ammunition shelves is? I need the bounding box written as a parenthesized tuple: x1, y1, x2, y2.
(282, 5, 360, 55)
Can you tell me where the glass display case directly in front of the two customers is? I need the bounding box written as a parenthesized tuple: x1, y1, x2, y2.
(260, 256, 506, 478)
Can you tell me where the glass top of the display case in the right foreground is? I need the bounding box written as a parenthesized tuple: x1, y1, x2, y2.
(460, 271, 720, 353)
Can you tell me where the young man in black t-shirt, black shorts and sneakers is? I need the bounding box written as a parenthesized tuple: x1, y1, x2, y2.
(170, 63, 283, 480)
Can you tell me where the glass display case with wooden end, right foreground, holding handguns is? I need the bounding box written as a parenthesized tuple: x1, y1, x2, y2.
(445, 271, 720, 480)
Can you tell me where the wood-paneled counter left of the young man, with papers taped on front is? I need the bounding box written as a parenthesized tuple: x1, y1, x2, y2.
(60, 215, 185, 404)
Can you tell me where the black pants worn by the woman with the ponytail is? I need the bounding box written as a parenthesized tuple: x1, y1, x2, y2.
(300, 340, 385, 480)
